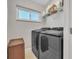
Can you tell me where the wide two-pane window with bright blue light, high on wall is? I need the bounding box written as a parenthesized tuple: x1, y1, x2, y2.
(16, 7, 41, 22)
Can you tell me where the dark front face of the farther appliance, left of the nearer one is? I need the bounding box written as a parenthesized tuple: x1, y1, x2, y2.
(32, 31, 39, 57)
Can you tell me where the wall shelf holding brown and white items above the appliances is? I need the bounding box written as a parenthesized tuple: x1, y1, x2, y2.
(42, 1, 63, 18)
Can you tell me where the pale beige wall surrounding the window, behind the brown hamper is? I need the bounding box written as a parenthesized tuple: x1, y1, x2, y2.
(7, 0, 43, 48)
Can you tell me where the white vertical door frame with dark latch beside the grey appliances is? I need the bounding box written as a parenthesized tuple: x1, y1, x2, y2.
(64, 0, 72, 59)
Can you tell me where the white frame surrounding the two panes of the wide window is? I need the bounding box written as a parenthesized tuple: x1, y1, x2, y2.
(16, 5, 42, 22)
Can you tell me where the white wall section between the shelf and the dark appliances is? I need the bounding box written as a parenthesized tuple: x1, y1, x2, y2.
(46, 12, 64, 27)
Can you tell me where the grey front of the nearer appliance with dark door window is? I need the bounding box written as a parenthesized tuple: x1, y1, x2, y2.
(39, 34, 63, 59)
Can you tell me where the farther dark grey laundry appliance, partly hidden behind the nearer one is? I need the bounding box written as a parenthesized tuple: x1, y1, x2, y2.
(31, 28, 51, 58)
